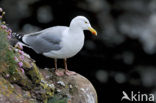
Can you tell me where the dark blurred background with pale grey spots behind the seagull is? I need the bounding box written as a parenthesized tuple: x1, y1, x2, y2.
(0, 0, 156, 103)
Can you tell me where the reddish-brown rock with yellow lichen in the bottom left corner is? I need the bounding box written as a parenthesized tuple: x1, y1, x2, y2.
(0, 76, 37, 103)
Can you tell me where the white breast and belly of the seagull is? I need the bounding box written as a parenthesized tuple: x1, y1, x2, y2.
(44, 28, 84, 59)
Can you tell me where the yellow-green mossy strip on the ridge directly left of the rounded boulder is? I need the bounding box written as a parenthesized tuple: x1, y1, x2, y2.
(26, 63, 54, 103)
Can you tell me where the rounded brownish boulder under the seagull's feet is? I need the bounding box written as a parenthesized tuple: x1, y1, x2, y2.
(40, 69, 97, 103)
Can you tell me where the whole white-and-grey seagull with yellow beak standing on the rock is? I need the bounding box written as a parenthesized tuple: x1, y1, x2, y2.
(14, 16, 97, 76)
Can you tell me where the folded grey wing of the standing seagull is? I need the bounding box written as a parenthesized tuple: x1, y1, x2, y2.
(25, 27, 67, 53)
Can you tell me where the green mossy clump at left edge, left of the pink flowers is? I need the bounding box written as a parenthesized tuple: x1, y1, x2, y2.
(0, 28, 21, 85)
